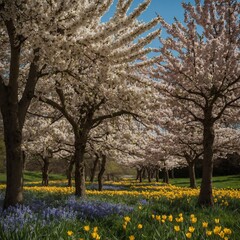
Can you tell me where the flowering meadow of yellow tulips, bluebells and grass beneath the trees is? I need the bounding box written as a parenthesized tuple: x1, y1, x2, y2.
(0, 173, 240, 240)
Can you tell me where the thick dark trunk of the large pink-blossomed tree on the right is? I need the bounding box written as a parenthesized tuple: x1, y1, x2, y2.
(198, 119, 215, 206)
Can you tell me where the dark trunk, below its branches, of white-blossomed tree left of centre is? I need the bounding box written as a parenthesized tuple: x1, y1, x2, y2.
(74, 140, 86, 197)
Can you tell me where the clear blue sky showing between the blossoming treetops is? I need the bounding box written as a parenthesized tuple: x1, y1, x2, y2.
(102, 0, 195, 47)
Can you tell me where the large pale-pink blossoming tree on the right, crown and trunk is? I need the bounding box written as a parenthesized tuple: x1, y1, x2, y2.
(155, 0, 240, 206)
